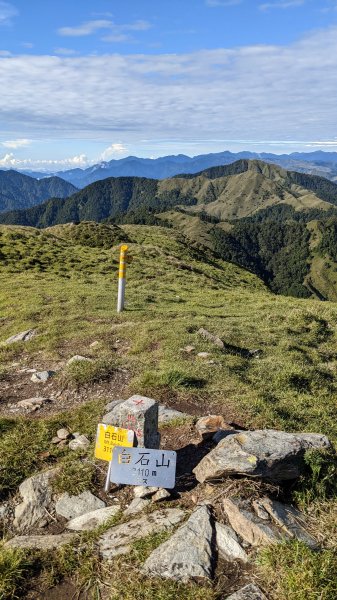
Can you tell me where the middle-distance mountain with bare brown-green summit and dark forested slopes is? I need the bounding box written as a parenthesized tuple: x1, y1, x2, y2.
(0, 159, 337, 301)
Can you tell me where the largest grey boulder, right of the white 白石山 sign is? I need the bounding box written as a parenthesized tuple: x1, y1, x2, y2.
(193, 429, 331, 483)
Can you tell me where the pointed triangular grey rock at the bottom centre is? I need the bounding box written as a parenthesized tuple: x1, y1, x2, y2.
(142, 506, 213, 582)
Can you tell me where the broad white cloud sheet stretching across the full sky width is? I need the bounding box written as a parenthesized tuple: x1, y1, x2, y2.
(0, 27, 337, 146)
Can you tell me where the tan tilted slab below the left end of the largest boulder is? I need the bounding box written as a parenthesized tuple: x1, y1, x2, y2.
(223, 498, 281, 546)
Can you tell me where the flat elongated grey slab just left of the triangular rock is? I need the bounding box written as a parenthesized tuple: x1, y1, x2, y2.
(98, 508, 185, 560)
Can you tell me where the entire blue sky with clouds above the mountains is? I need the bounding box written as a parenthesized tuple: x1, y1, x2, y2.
(0, 0, 337, 170)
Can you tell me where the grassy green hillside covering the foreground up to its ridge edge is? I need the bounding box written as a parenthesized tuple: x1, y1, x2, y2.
(0, 223, 337, 600)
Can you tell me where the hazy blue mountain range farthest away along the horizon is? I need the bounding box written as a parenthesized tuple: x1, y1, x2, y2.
(15, 150, 337, 188)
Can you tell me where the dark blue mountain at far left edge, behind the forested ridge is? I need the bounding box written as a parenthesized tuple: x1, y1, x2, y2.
(0, 170, 77, 212)
